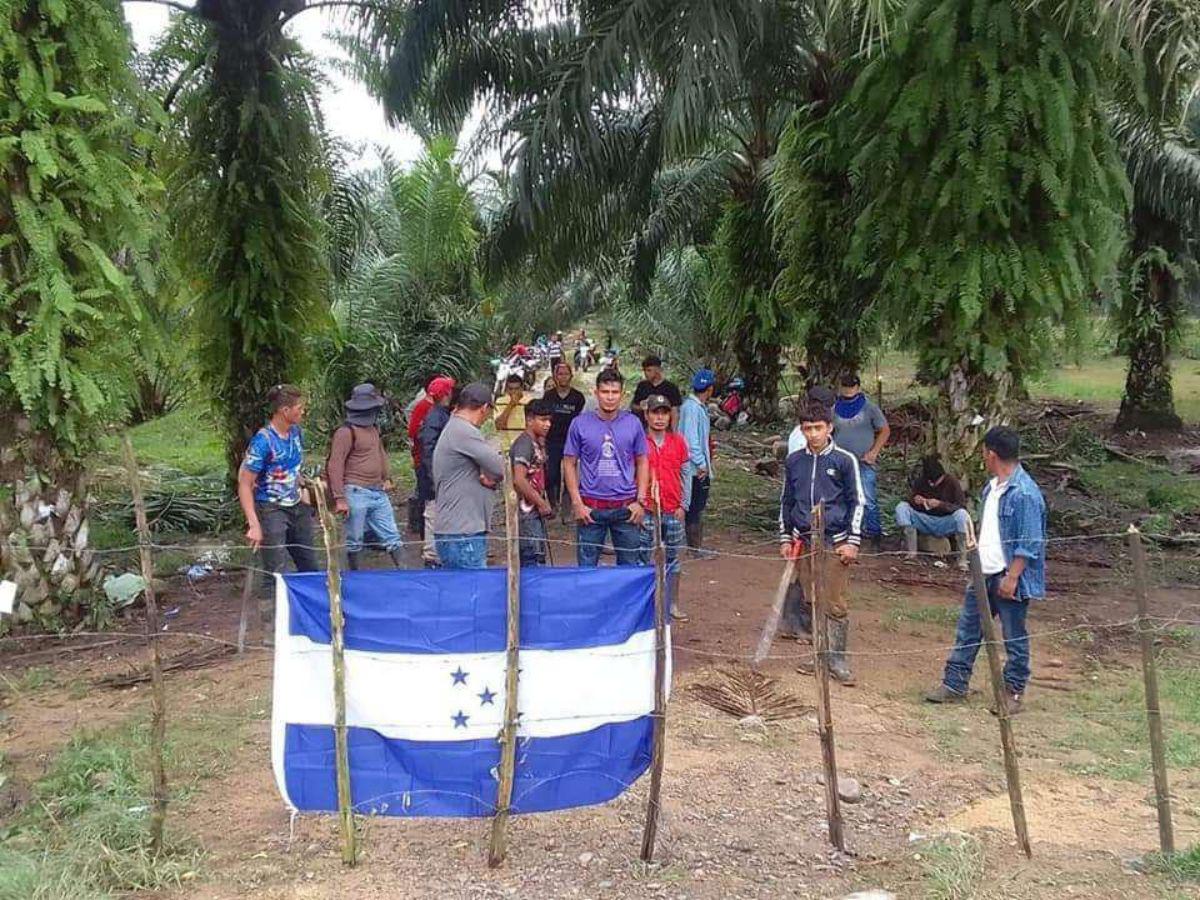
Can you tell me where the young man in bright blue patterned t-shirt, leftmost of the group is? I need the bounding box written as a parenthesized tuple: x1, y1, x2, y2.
(238, 384, 318, 594)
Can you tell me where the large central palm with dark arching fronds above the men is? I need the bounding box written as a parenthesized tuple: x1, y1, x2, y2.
(374, 0, 883, 418)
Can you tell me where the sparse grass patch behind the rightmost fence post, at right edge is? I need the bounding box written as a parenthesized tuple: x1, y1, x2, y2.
(1057, 658, 1200, 781)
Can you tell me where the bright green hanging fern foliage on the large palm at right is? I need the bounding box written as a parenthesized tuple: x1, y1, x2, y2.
(842, 0, 1128, 393)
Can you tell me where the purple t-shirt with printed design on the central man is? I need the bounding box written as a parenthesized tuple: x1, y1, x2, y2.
(563, 410, 646, 502)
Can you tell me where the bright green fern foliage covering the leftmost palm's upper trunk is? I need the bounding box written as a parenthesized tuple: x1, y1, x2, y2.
(0, 0, 156, 462)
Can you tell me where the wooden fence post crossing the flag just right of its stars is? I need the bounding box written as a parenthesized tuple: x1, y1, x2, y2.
(487, 461, 521, 869)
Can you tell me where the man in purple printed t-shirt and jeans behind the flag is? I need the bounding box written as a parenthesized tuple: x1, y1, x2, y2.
(563, 368, 650, 566)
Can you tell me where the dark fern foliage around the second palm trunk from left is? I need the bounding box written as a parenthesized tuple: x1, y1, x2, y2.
(164, 10, 330, 470)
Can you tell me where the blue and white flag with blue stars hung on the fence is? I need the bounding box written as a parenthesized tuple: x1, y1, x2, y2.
(271, 566, 670, 816)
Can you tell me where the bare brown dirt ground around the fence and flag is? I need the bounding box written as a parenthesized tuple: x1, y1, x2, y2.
(0, 532, 1200, 900)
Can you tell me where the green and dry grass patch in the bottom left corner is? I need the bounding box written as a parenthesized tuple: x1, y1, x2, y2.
(0, 701, 265, 900)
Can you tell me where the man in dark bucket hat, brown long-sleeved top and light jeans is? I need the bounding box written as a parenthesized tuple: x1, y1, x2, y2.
(326, 384, 402, 569)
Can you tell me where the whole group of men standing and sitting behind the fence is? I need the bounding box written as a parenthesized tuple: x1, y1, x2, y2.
(239, 356, 1045, 714)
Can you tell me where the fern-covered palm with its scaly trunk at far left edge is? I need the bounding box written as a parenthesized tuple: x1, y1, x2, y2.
(0, 0, 152, 628)
